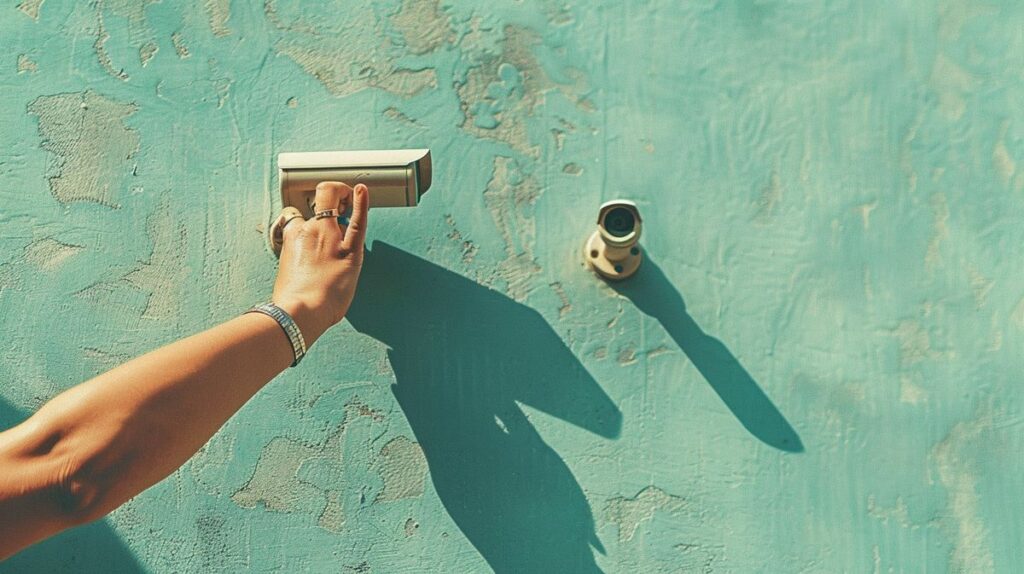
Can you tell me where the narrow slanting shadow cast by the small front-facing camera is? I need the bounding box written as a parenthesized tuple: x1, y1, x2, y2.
(610, 259, 804, 452)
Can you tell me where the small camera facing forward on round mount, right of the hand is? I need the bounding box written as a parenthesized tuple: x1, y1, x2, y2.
(584, 200, 643, 280)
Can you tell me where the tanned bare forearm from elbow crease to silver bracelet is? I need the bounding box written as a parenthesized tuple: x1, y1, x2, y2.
(18, 306, 318, 519)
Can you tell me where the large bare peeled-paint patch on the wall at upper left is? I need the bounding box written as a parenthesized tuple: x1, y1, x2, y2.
(28, 90, 139, 208)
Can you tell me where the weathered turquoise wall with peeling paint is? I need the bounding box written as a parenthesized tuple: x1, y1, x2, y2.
(0, 0, 1024, 573)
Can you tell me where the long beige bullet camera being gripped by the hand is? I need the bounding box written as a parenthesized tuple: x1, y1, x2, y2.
(268, 149, 432, 255)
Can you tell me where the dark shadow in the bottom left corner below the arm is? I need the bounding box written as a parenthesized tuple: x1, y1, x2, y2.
(0, 399, 145, 574)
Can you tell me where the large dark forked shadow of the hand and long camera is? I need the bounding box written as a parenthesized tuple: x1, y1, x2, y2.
(347, 241, 622, 572)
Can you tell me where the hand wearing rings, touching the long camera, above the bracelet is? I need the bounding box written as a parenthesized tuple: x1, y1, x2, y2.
(271, 181, 370, 347)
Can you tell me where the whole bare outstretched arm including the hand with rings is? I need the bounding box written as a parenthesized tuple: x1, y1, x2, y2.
(0, 182, 369, 560)
